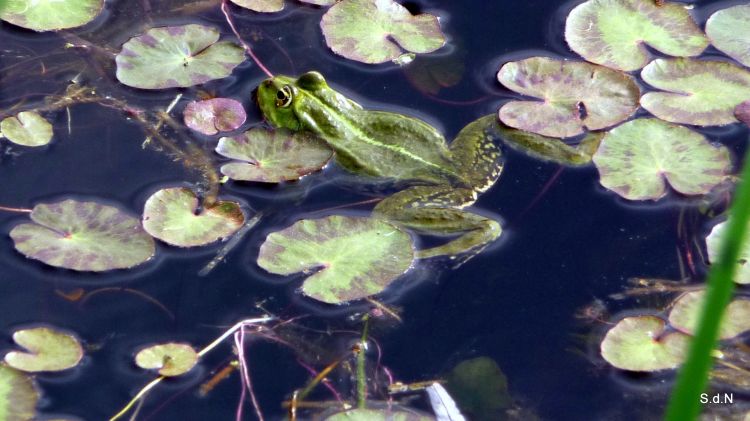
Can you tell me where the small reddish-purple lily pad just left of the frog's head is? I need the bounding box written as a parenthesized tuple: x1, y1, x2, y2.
(183, 98, 247, 136)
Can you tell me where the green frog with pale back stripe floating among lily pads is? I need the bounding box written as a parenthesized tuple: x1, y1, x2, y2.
(257, 72, 502, 262)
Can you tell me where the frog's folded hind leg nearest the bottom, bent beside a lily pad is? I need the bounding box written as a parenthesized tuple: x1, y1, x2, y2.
(373, 186, 502, 261)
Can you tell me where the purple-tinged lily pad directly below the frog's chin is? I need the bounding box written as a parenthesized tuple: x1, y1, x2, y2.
(216, 128, 333, 183)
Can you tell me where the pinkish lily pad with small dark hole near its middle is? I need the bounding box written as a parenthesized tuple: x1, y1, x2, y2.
(497, 57, 640, 137)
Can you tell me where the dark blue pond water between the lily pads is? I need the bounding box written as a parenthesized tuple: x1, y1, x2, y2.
(0, 0, 746, 420)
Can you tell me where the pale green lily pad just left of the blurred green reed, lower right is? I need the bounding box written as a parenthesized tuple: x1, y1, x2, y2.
(601, 316, 690, 371)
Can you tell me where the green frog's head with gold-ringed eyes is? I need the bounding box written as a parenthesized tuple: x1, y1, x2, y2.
(258, 72, 327, 130)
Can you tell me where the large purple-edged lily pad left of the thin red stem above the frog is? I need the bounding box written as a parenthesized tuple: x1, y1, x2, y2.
(115, 24, 245, 89)
